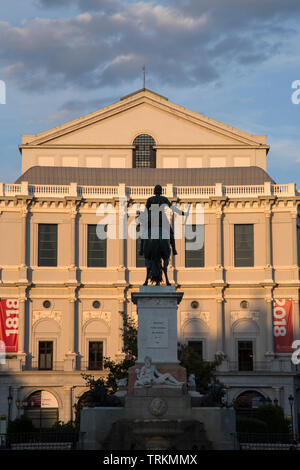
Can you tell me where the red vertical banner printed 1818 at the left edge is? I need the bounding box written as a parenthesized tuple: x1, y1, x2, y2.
(0, 299, 19, 353)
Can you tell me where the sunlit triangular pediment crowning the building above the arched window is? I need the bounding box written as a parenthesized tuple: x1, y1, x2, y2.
(21, 89, 267, 148)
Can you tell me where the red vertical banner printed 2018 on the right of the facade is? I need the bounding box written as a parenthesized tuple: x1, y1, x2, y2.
(273, 299, 294, 353)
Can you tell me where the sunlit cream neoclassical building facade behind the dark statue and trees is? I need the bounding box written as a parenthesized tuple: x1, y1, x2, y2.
(0, 89, 300, 430)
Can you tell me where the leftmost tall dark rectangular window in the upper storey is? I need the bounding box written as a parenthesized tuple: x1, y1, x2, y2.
(38, 224, 57, 266)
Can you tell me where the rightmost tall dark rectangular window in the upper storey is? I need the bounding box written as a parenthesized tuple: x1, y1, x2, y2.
(234, 224, 254, 267)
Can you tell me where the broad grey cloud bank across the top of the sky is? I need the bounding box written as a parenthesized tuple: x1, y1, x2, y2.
(0, 0, 300, 92)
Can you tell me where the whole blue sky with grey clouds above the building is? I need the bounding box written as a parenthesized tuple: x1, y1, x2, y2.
(0, 0, 300, 184)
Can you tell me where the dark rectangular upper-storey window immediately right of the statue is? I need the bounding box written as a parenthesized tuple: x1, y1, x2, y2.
(185, 225, 204, 268)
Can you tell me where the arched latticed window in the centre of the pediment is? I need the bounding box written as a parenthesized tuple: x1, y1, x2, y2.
(132, 134, 156, 168)
